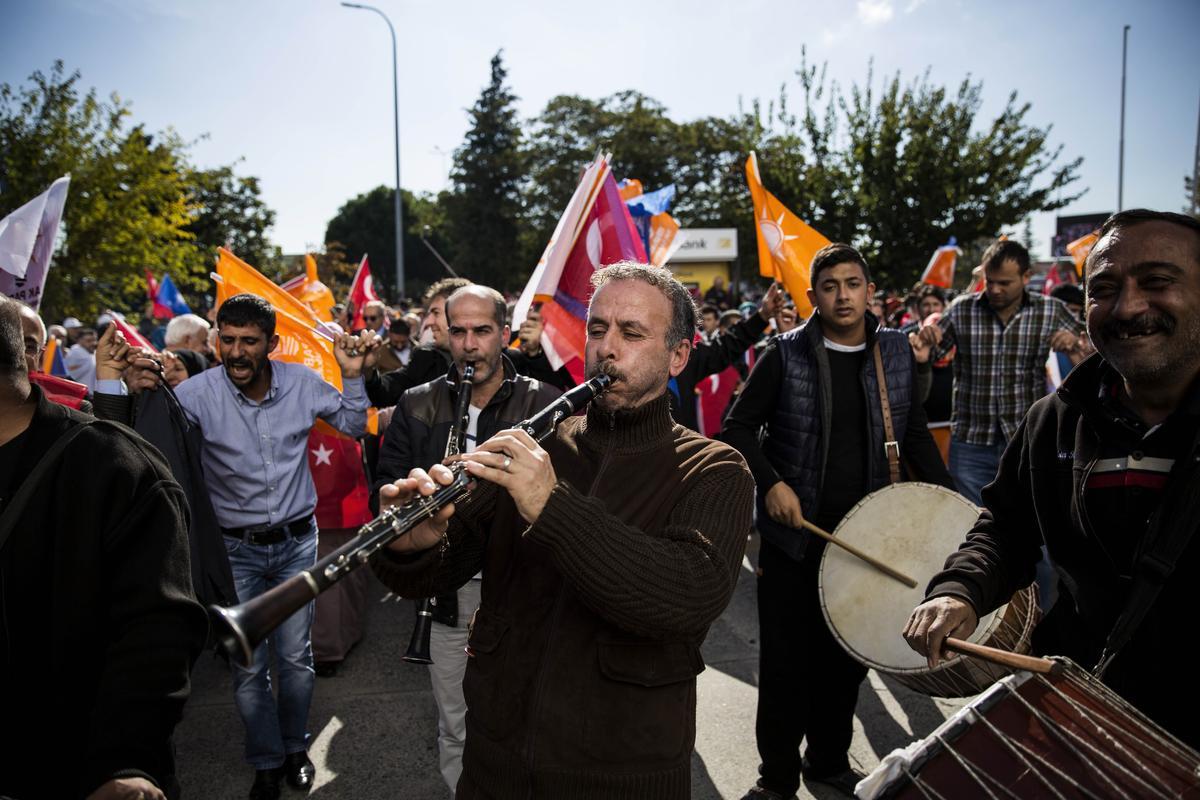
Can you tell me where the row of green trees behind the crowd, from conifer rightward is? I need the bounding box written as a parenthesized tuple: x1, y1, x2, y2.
(330, 50, 1081, 297)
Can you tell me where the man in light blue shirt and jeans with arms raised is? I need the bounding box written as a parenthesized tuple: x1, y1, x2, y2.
(175, 294, 379, 799)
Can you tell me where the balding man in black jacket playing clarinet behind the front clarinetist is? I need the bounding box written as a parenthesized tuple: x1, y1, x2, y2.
(377, 285, 560, 792)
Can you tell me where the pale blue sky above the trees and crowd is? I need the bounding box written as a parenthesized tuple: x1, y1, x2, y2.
(0, 0, 1200, 263)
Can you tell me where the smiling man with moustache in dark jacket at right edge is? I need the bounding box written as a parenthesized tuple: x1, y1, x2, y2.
(904, 210, 1200, 747)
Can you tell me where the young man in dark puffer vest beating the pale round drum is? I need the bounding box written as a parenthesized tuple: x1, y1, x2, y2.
(725, 245, 953, 800)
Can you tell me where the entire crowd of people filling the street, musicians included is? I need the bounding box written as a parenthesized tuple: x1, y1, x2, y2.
(0, 211, 1200, 800)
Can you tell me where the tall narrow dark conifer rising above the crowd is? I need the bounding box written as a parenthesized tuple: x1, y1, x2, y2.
(444, 53, 533, 289)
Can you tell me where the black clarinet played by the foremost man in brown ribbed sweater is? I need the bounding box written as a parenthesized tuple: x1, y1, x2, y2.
(209, 373, 612, 666)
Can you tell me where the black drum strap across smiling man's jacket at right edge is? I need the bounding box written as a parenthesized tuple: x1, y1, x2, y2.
(1092, 451, 1200, 679)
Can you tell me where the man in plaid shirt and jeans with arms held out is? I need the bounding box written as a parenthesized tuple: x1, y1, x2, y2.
(908, 240, 1084, 505)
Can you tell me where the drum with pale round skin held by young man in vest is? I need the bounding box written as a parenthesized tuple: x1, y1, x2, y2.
(820, 482, 1038, 697)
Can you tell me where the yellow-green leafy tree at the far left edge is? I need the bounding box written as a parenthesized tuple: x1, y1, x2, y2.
(0, 61, 272, 319)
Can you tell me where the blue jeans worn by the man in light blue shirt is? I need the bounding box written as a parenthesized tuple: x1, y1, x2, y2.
(224, 522, 317, 770)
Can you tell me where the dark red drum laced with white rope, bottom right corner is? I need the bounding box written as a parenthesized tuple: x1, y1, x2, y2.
(854, 658, 1200, 800)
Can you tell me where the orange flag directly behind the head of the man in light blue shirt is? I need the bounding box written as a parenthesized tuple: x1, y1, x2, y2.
(214, 247, 342, 391)
